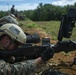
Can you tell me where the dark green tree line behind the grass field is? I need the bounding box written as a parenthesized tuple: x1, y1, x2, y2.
(0, 3, 76, 21)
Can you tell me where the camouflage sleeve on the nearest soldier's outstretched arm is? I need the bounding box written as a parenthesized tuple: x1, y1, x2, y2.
(0, 60, 36, 75)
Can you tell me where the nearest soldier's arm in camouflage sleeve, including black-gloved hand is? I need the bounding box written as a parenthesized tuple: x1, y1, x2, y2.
(0, 48, 54, 75)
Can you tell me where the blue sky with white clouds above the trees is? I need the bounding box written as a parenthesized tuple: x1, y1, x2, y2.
(0, 0, 76, 11)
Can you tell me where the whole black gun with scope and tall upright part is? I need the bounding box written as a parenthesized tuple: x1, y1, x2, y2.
(0, 9, 76, 62)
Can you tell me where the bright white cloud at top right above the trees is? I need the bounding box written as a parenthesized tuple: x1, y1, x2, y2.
(52, 0, 76, 6)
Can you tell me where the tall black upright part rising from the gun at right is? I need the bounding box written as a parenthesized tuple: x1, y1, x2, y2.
(58, 9, 76, 41)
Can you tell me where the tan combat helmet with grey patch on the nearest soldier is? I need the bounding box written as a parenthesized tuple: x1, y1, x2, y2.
(0, 23, 26, 44)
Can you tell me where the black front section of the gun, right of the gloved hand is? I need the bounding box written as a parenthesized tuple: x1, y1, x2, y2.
(52, 40, 76, 53)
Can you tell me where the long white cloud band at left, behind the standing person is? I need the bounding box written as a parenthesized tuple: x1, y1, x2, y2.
(0, 4, 38, 11)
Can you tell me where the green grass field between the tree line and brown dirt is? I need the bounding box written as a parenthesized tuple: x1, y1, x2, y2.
(19, 19, 76, 40)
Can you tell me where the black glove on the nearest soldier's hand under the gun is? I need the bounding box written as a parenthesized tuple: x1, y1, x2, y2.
(41, 47, 54, 61)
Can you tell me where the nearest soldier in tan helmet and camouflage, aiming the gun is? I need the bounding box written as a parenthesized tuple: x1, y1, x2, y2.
(0, 23, 54, 75)
